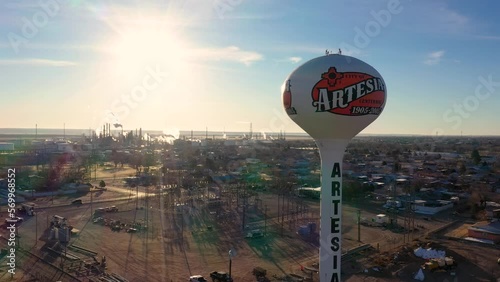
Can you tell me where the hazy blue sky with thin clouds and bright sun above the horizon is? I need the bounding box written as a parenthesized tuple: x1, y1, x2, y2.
(0, 0, 500, 135)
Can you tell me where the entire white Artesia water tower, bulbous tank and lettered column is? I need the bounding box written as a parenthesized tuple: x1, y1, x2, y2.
(282, 55, 386, 282)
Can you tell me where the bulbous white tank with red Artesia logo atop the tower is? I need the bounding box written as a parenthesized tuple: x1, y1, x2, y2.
(282, 55, 386, 139)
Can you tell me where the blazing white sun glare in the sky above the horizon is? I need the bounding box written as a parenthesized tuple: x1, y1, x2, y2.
(96, 13, 211, 128)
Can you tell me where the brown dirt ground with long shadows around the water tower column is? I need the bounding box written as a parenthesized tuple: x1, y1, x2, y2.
(2, 169, 500, 282)
